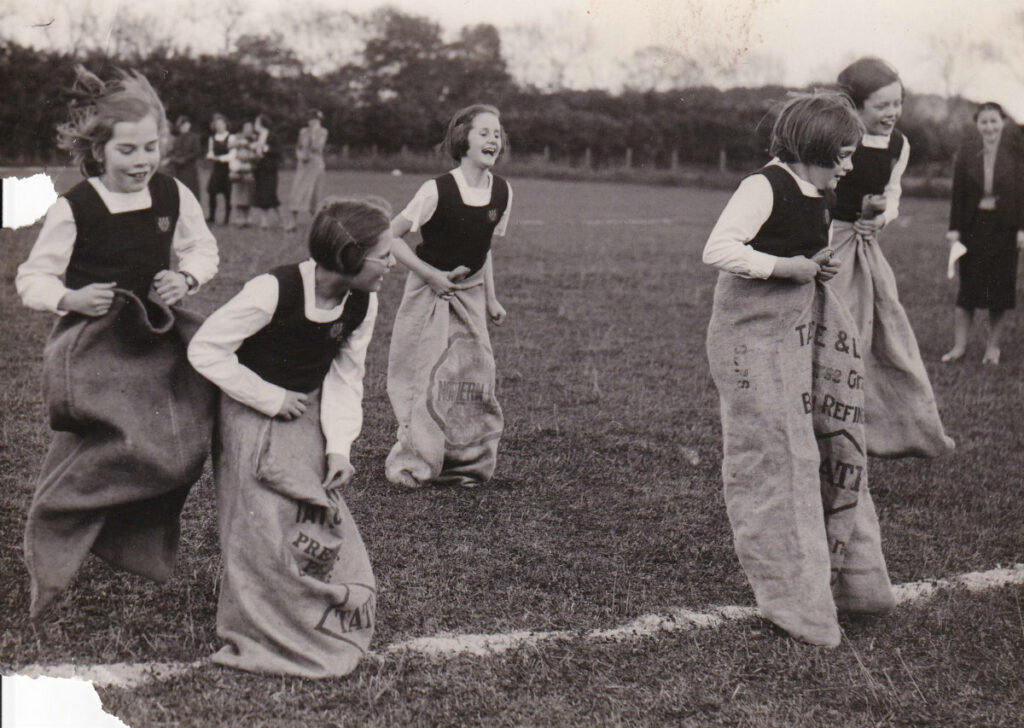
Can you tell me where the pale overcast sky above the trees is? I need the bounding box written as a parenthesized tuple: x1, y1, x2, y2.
(8, 0, 1024, 119)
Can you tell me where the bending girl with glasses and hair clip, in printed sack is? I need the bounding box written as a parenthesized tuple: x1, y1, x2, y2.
(188, 195, 394, 678)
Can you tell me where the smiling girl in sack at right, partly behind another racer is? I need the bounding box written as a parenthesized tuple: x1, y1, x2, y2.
(828, 56, 953, 458)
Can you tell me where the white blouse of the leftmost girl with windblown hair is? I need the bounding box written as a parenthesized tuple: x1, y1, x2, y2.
(14, 177, 220, 315)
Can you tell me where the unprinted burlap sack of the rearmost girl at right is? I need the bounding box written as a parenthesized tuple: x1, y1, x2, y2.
(827, 220, 953, 458)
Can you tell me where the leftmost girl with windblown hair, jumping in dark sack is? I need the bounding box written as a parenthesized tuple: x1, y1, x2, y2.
(15, 66, 218, 616)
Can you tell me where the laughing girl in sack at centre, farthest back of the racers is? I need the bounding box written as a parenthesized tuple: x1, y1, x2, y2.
(385, 104, 512, 488)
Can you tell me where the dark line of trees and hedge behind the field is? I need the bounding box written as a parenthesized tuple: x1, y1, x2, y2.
(0, 9, 983, 174)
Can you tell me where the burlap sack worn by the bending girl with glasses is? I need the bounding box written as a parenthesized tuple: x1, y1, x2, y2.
(213, 391, 377, 678)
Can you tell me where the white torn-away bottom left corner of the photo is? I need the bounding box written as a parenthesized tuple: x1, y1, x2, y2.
(0, 675, 129, 728)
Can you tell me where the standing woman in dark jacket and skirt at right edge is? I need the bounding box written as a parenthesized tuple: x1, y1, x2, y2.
(942, 101, 1024, 365)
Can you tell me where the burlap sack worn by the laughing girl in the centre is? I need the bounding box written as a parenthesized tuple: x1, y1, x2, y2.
(385, 270, 505, 485)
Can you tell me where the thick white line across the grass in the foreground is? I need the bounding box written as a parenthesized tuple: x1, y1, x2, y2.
(15, 564, 1024, 687)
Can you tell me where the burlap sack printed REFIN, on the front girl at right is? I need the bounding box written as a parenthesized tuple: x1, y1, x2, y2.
(708, 273, 894, 646)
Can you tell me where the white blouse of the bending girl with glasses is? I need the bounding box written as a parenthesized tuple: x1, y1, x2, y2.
(188, 259, 378, 458)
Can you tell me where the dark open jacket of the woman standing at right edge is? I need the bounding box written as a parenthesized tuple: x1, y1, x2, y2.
(949, 129, 1024, 233)
